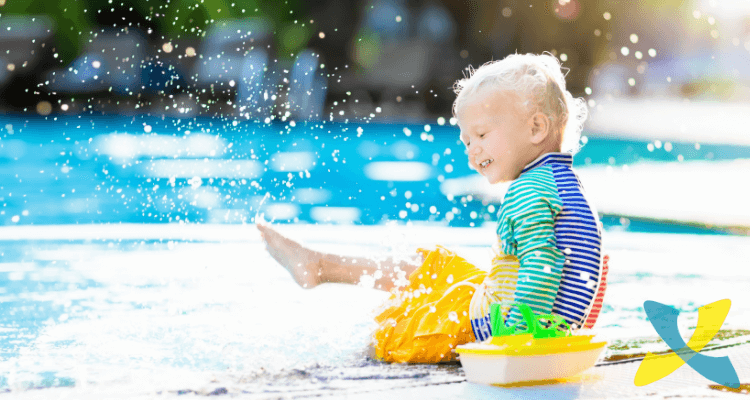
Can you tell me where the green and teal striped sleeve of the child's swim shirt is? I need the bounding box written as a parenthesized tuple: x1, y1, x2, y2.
(497, 165, 565, 325)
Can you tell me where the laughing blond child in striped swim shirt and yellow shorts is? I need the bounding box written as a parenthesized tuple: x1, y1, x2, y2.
(258, 54, 607, 363)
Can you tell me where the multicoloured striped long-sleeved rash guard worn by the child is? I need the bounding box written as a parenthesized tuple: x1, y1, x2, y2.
(470, 153, 602, 341)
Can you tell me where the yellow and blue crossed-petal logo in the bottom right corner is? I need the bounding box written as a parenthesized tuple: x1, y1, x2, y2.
(635, 299, 740, 388)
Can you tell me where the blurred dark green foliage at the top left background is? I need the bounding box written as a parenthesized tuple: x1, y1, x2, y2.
(0, 0, 314, 64)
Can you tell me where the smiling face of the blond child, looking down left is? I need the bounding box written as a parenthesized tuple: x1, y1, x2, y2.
(457, 90, 534, 183)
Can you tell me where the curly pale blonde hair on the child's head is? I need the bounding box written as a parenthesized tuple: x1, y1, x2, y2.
(453, 53, 588, 153)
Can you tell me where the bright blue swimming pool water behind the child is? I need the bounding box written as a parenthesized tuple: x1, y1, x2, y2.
(0, 116, 750, 232)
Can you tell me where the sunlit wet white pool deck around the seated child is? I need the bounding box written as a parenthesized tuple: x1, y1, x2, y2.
(0, 224, 750, 399)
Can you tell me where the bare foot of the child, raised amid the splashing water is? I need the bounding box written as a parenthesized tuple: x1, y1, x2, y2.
(256, 224, 323, 289)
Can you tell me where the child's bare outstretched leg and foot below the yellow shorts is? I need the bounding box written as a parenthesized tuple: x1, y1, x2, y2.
(257, 225, 424, 291)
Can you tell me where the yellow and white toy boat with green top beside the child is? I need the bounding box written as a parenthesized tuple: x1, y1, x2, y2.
(456, 303, 607, 385)
